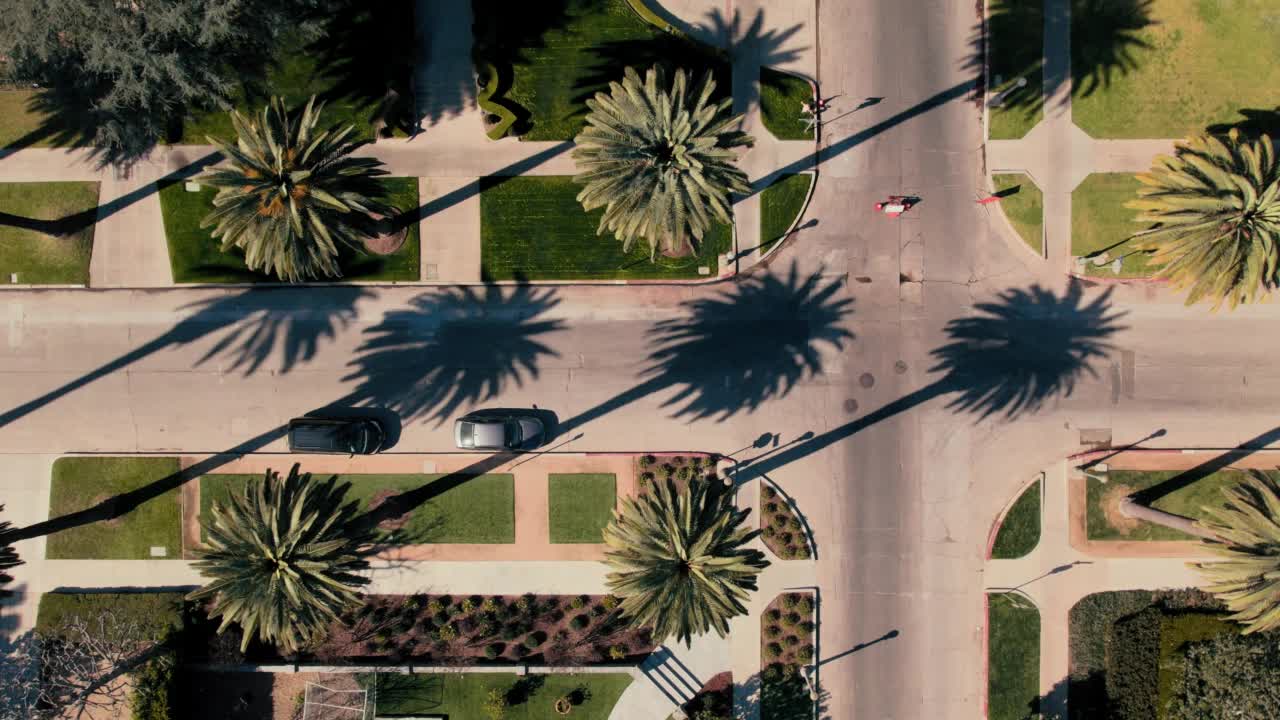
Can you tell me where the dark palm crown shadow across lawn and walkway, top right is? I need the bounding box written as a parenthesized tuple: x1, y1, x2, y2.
(965, 0, 1155, 113)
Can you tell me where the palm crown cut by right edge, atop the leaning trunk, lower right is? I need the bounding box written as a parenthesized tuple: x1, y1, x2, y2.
(1194, 470, 1280, 633)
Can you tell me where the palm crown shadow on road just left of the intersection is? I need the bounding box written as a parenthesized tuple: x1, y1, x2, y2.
(645, 264, 854, 420)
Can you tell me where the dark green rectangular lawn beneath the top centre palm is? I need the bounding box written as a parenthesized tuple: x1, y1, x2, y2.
(480, 176, 733, 281)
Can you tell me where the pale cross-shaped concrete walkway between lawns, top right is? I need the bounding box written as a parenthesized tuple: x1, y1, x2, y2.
(987, 0, 1174, 273)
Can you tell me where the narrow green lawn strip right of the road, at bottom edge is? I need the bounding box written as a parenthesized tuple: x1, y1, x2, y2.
(987, 593, 1039, 720)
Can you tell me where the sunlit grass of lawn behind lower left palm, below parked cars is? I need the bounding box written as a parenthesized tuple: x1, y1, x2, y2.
(200, 474, 516, 544)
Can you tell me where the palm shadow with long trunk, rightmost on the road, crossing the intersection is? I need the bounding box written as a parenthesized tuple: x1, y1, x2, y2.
(733, 283, 1124, 482)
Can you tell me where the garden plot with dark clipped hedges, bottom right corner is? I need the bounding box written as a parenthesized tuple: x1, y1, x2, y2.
(1068, 589, 1239, 720)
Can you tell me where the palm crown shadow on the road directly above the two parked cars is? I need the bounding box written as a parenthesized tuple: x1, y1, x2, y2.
(343, 284, 564, 425)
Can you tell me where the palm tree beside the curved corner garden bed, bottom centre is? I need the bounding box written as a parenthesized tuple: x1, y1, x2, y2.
(604, 478, 769, 643)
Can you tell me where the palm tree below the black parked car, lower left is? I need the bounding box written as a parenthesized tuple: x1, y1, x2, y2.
(187, 465, 374, 655)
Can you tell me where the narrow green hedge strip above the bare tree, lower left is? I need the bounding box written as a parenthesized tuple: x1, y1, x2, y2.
(36, 591, 183, 639)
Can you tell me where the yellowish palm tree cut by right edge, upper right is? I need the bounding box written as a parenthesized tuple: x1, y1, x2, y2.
(1128, 129, 1280, 309)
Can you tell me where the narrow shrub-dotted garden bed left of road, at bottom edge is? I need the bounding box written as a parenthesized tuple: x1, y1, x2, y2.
(760, 592, 818, 720)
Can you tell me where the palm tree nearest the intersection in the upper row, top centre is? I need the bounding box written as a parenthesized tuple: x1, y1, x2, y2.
(573, 65, 753, 260)
